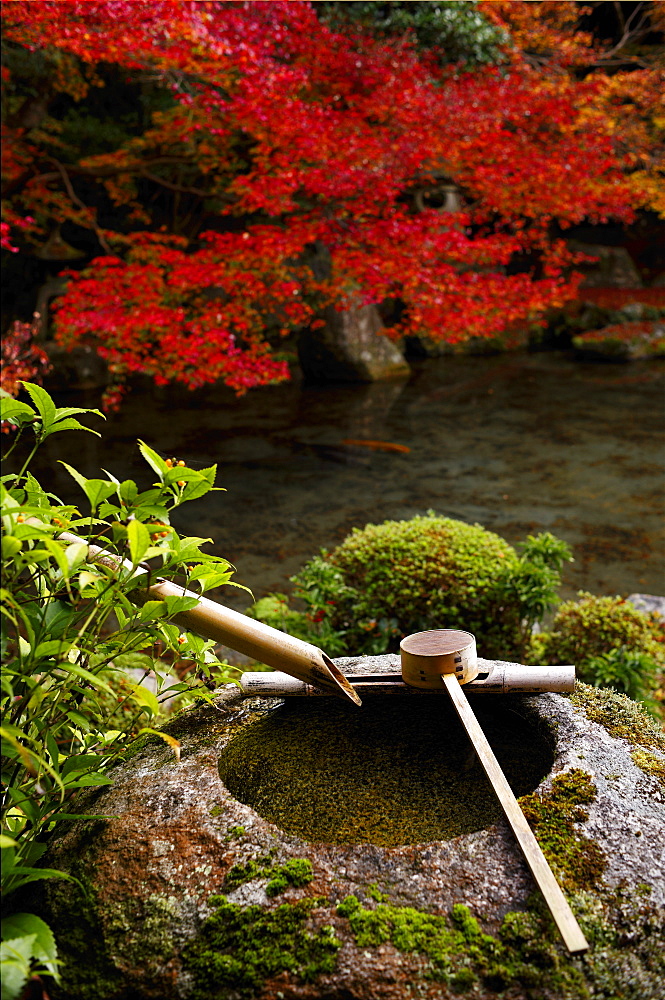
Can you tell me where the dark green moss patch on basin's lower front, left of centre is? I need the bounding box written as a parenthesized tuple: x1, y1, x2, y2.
(183, 896, 341, 1000)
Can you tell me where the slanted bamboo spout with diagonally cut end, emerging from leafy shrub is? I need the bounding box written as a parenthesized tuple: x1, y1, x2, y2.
(59, 532, 361, 705)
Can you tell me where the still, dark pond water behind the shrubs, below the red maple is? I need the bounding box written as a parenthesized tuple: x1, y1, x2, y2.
(44, 352, 665, 609)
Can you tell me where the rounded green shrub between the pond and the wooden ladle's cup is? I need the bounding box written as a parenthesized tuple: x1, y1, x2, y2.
(253, 512, 570, 659)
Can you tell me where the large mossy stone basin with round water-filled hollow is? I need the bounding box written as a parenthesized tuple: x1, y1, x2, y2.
(28, 656, 665, 1000)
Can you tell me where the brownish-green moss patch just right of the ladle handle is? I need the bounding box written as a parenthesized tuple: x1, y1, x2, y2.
(520, 769, 607, 890)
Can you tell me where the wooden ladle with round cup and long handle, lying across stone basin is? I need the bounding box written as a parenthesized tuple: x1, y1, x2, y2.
(400, 629, 589, 955)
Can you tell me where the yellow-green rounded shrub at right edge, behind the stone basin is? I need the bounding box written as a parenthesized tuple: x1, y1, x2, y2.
(539, 591, 665, 710)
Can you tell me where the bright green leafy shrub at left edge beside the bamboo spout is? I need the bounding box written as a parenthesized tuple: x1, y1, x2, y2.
(0, 383, 239, 992)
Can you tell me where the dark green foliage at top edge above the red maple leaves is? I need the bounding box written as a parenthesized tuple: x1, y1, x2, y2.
(315, 0, 507, 69)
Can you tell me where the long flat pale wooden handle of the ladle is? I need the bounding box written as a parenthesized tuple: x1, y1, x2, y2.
(441, 674, 589, 955)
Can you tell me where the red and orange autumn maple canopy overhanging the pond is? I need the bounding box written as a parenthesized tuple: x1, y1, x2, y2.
(2, 0, 663, 402)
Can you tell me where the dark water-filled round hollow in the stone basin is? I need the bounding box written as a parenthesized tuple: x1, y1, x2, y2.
(219, 693, 553, 847)
